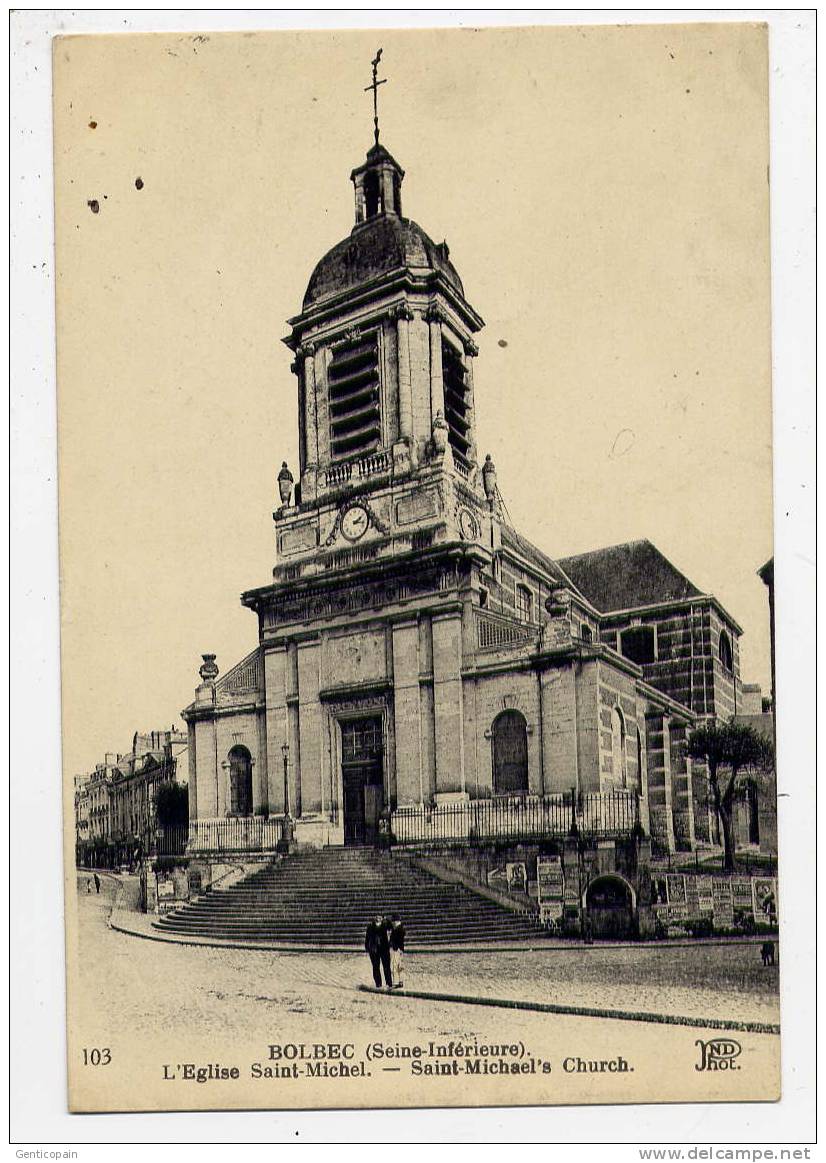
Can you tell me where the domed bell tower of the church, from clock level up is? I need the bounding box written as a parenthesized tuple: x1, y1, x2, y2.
(266, 104, 490, 580)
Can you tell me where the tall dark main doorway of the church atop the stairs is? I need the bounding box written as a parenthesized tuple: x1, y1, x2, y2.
(341, 715, 384, 846)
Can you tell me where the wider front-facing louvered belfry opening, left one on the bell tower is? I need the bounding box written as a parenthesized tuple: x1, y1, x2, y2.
(327, 335, 382, 461)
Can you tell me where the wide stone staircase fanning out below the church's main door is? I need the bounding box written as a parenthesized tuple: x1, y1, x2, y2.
(155, 848, 542, 949)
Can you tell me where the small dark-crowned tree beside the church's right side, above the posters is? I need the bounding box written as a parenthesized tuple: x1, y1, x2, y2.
(685, 722, 775, 872)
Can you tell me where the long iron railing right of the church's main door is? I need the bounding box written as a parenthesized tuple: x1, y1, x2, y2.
(390, 790, 640, 846)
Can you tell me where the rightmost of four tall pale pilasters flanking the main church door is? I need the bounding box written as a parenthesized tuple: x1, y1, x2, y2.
(433, 611, 465, 802)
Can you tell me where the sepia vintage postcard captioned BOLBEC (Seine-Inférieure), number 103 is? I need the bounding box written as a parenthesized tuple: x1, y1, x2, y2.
(54, 22, 782, 1112)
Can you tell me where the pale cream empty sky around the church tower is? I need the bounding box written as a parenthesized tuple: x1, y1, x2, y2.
(55, 23, 772, 777)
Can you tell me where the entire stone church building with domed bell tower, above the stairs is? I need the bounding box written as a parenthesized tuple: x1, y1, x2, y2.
(183, 141, 741, 865)
